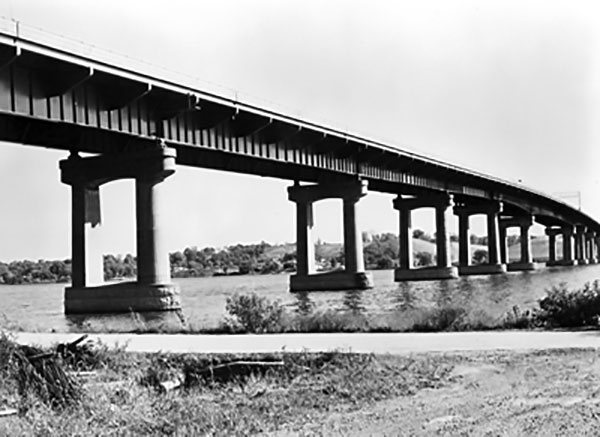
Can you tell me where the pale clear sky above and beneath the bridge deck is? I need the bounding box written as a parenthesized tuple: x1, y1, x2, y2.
(0, 0, 600, 260)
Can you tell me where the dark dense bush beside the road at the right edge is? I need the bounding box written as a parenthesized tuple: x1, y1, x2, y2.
(537, 281, 600, 328)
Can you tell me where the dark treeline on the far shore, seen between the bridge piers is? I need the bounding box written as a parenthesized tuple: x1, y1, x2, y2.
(0, 229, 515, 284)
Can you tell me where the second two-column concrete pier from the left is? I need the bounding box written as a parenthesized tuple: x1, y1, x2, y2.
(288, 180, 373, 292)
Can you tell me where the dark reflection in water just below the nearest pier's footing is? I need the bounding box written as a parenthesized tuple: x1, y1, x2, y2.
(65, 311, 186, 332)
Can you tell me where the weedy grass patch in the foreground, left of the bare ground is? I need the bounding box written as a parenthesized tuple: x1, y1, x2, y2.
(0, 332, 451, 436)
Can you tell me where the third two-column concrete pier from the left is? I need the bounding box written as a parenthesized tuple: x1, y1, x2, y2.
(394, 193, 458, 281)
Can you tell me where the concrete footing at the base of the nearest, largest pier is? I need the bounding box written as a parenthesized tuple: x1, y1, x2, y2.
(64, 282, 181, 314)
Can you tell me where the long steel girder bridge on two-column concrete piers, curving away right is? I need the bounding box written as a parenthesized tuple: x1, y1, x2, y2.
(0, 23, 600, 313)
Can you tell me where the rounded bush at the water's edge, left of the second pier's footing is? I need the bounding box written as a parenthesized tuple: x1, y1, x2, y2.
(225, 293, 285, 333)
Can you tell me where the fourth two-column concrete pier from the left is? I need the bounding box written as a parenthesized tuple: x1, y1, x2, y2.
(454, 201, 506, 276)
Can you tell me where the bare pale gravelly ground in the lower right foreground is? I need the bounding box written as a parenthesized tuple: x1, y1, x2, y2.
(274, 350, 600, 436)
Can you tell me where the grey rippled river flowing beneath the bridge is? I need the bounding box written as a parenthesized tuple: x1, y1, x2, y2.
(0, 264, 600, 332)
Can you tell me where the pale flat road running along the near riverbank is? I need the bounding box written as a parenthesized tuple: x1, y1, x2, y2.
(14, 331, 600, 355)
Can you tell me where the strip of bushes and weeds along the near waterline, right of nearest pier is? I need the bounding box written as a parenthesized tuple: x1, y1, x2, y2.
(217, 281, 600, 333)
